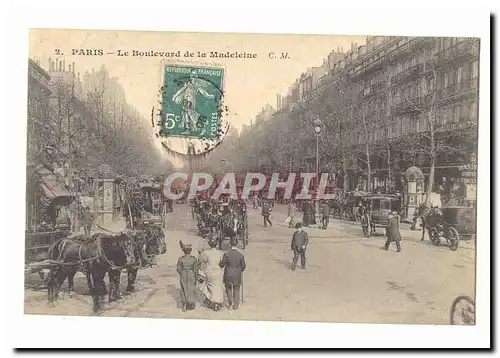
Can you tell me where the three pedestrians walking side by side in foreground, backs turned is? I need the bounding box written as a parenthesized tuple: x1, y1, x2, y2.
(177, 238, 246, 311)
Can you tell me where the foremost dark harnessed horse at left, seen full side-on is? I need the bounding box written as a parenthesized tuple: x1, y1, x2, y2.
(47, 233, 137, 312)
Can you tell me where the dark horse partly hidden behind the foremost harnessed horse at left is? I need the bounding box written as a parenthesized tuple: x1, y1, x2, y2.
(121, 225, 167, 293)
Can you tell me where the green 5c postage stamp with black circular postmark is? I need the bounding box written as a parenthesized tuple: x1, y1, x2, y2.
(160, 65, 225, 140)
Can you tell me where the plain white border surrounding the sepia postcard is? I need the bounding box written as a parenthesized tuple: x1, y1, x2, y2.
(0, 1, 490, 348)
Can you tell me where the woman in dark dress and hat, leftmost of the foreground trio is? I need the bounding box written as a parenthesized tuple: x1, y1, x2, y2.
(177, 242, 198, 311)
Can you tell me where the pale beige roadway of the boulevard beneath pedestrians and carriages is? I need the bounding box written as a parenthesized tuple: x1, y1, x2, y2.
(25, 205, 475, 324)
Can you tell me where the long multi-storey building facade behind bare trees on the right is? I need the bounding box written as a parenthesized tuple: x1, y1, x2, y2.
(252, 36, 479, 198)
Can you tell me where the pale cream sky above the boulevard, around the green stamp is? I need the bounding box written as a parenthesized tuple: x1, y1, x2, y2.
(29, 29, 365, 129)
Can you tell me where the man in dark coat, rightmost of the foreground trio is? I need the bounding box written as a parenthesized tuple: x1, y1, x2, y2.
(219, 238, 247, 310)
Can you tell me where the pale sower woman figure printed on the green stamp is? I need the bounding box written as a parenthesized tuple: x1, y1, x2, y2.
(172, 70, 214, 135)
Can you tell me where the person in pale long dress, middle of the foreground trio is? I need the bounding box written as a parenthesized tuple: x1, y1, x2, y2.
(198, 239, 224, 311)
